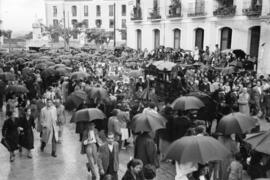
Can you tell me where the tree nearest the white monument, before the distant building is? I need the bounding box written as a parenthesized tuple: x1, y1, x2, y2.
(45, 25, 80, 50)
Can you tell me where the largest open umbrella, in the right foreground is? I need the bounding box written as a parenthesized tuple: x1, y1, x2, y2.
(166, 136, 230, 164)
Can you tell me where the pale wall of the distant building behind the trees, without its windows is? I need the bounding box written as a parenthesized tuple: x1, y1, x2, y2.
(45, 0, 130, 44)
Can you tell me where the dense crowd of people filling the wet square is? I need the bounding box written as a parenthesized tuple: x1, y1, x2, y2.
(0, 46, 270, 180)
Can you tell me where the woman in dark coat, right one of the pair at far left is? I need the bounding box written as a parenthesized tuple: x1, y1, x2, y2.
(19, 108, 35, 159)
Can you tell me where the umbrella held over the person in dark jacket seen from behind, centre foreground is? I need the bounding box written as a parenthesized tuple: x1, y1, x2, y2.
(131, 111, 166, 132)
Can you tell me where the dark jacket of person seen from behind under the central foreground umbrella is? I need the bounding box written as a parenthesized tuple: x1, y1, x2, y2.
(134, 133, 159, 168)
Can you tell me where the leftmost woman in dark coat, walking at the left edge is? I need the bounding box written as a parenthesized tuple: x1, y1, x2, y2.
(2, 111, 22, 162)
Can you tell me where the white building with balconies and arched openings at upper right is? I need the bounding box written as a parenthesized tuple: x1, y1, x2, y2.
(127, 0, 270, 74)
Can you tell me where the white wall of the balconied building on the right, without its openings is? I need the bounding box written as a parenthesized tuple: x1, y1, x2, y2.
(127, 0, 270, 52)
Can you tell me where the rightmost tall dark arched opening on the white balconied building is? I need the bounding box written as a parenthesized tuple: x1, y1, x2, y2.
(249, 26, 261, 57)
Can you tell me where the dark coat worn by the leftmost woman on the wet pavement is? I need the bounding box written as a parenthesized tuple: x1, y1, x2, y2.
(2, 119, 19, 151)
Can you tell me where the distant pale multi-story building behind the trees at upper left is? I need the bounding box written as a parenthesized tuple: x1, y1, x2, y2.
(44, 0, 130, 44)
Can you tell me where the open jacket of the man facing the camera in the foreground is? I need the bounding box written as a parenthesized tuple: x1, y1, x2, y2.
(98, 142, 119, 173)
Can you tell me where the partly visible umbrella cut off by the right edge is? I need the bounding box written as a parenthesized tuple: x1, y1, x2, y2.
(245, 130, 270, 155)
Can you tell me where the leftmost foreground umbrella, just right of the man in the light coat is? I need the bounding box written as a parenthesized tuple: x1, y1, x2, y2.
(71, 108, 106, 123)
